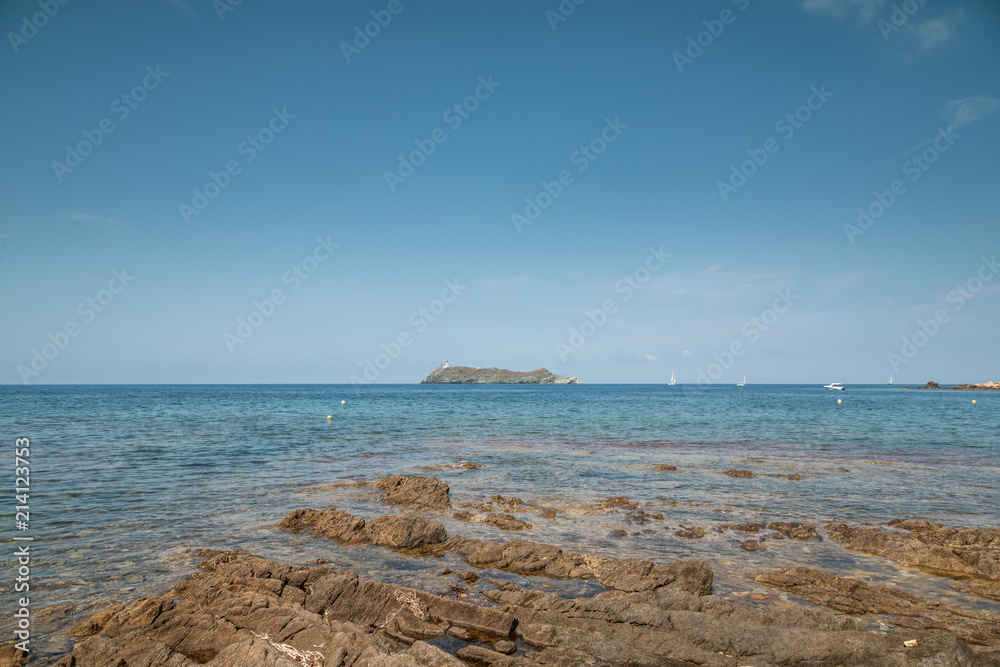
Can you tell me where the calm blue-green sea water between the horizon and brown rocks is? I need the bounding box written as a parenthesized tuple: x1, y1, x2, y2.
(0, 385, 1000, 653)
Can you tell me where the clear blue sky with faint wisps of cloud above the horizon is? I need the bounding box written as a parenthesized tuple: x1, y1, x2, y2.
(0, 0, 1000, 384)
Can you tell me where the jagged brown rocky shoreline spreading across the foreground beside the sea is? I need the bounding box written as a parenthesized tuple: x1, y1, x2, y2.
(13, 475, 1000, 667)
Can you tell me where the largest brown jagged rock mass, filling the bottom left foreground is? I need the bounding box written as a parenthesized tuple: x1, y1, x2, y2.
(57, 552, 516, 667)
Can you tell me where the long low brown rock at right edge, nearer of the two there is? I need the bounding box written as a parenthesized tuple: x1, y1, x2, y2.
(754, 567, 1000, 646)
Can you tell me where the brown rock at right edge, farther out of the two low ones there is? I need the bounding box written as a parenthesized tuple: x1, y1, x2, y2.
(826, 519, 1000, 581)
